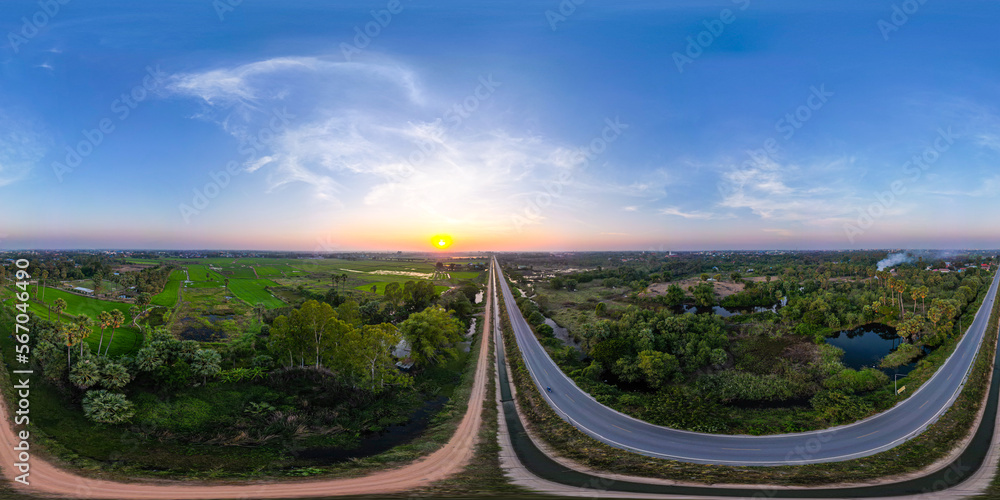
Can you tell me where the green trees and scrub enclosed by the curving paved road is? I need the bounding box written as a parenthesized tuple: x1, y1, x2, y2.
(511, 252, 992, 435)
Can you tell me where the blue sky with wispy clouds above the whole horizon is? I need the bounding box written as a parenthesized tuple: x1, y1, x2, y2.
(0, 0, 1000, 250)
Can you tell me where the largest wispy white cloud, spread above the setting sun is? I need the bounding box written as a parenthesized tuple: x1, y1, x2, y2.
(169, 53, 584, 233)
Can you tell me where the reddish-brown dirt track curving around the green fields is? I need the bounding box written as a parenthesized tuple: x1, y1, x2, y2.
(0, 268, 492, 499)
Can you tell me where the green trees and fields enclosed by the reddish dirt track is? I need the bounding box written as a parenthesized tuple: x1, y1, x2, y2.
(0, 252, 481, 478)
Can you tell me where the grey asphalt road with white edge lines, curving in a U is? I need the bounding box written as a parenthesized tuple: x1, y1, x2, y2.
(497, 258, 1000, 465)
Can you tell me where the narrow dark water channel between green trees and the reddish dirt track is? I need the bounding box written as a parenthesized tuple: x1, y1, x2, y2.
(298, 396, 448, 465)
